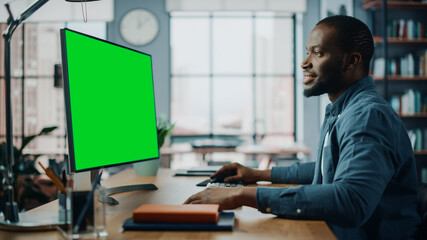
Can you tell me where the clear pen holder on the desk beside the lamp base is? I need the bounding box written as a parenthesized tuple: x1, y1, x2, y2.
(58, 187, 108, 239)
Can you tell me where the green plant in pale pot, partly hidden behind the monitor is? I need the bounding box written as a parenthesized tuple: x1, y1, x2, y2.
(133, 117, 175, 176)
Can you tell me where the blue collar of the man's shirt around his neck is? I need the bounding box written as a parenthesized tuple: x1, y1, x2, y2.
(326, 76, 375, 117)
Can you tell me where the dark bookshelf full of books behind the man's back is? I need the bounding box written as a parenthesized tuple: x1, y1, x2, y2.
(362, 0, 427, 178)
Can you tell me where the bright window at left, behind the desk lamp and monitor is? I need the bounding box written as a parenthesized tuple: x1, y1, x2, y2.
(0, 22, 106, 157)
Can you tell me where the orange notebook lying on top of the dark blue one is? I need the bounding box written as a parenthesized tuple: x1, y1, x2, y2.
(133, 204, 219, 223)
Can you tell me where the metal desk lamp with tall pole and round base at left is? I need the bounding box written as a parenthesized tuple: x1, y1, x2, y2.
(0, 0, 99, 231)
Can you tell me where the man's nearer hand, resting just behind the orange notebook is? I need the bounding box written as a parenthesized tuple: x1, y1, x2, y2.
(184, 187, 256, 210)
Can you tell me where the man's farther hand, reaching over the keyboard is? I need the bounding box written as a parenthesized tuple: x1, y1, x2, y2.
(211, 163, 271, 183)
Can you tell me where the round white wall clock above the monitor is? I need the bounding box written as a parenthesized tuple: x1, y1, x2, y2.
(120, 9, 159, 46)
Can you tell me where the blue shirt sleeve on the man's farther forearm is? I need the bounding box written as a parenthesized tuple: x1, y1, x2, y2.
(271, 162, 315, 184)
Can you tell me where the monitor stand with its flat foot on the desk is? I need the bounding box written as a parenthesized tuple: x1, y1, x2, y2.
(74, 170, 158, 205)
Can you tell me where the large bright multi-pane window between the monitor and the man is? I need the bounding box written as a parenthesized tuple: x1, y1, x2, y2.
(170, 11, 294, 140)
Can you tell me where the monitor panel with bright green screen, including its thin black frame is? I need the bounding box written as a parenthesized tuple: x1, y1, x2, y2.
(61, 29, 159, 172)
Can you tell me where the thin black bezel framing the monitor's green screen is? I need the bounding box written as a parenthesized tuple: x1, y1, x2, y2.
(60, 28, 160, 174)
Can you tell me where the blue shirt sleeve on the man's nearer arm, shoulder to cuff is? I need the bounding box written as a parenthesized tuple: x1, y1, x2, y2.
(256, 108, 397, 227)
